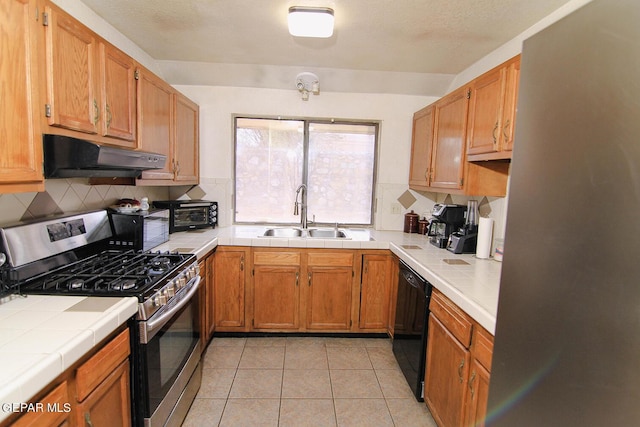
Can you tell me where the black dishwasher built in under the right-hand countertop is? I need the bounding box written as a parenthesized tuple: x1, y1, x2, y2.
(393, 260, 431, 401)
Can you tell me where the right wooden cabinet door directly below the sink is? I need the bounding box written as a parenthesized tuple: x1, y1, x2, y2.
(307, 266, 353, 330)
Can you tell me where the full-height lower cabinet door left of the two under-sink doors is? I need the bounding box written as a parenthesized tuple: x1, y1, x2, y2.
(213, 247, 247, 330)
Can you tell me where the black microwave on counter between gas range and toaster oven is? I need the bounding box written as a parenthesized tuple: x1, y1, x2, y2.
(109, 209, 169, 251)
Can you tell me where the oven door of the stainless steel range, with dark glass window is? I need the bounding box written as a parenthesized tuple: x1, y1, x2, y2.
(136, 276, 201, 426)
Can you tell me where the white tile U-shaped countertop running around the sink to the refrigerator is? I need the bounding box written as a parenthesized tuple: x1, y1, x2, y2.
(155, 225, 502, 334)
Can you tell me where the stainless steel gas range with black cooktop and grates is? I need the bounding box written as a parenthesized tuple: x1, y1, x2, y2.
(0, 210, 202, 426)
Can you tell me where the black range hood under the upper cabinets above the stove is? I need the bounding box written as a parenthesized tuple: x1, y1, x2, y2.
(43, 134, 167, 178)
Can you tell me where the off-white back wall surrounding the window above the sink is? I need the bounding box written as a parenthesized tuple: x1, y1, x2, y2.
(171, 85, 437, 230)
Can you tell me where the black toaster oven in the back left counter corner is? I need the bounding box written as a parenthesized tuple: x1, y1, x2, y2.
(153, 200, 218, 233)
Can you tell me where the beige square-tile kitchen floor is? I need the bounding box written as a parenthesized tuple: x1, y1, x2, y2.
(183, 337, 436, 427)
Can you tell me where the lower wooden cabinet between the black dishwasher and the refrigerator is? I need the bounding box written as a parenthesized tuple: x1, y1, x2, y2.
(425, 289, 493, 427)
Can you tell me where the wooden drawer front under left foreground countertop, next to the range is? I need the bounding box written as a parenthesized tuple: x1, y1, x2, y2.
(76, 329, 130, 402)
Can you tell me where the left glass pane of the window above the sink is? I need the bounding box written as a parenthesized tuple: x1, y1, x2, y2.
(235, 118, 304, 223)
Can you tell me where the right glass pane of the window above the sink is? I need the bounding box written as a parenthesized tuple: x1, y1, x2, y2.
(308, 122, 376, 224)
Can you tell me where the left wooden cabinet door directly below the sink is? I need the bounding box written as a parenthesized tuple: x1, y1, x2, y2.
(253, 265, 300, 329)
